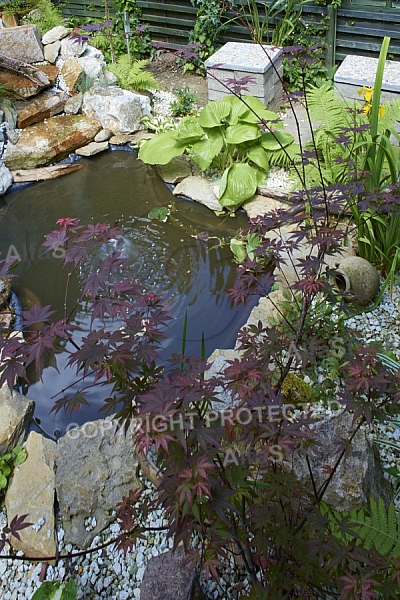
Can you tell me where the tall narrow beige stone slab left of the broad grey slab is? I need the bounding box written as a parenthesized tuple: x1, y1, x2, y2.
(5, 431, 56, 557)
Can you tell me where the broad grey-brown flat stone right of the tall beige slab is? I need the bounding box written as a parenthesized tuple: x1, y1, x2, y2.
(56, 418, 141, 548)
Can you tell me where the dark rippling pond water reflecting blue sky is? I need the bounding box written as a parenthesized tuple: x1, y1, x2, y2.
(0, 151, 256, 435)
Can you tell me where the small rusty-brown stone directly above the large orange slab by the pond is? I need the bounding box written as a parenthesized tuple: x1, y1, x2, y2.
(15, 91, 68, 129)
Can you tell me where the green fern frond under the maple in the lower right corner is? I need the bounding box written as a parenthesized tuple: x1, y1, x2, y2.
(350, 498, 400, 558)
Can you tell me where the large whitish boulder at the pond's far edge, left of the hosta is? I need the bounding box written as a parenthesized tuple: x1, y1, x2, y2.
(82, 86, 143, 134)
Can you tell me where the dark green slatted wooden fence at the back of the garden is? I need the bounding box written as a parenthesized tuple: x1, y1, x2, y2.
(58, 0, 400, 62)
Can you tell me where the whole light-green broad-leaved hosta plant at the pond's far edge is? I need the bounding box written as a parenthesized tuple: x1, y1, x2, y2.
(139, 95, 297, 211)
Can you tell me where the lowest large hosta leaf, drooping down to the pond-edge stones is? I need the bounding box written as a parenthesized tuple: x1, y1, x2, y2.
(219, 163, 257, 210)
